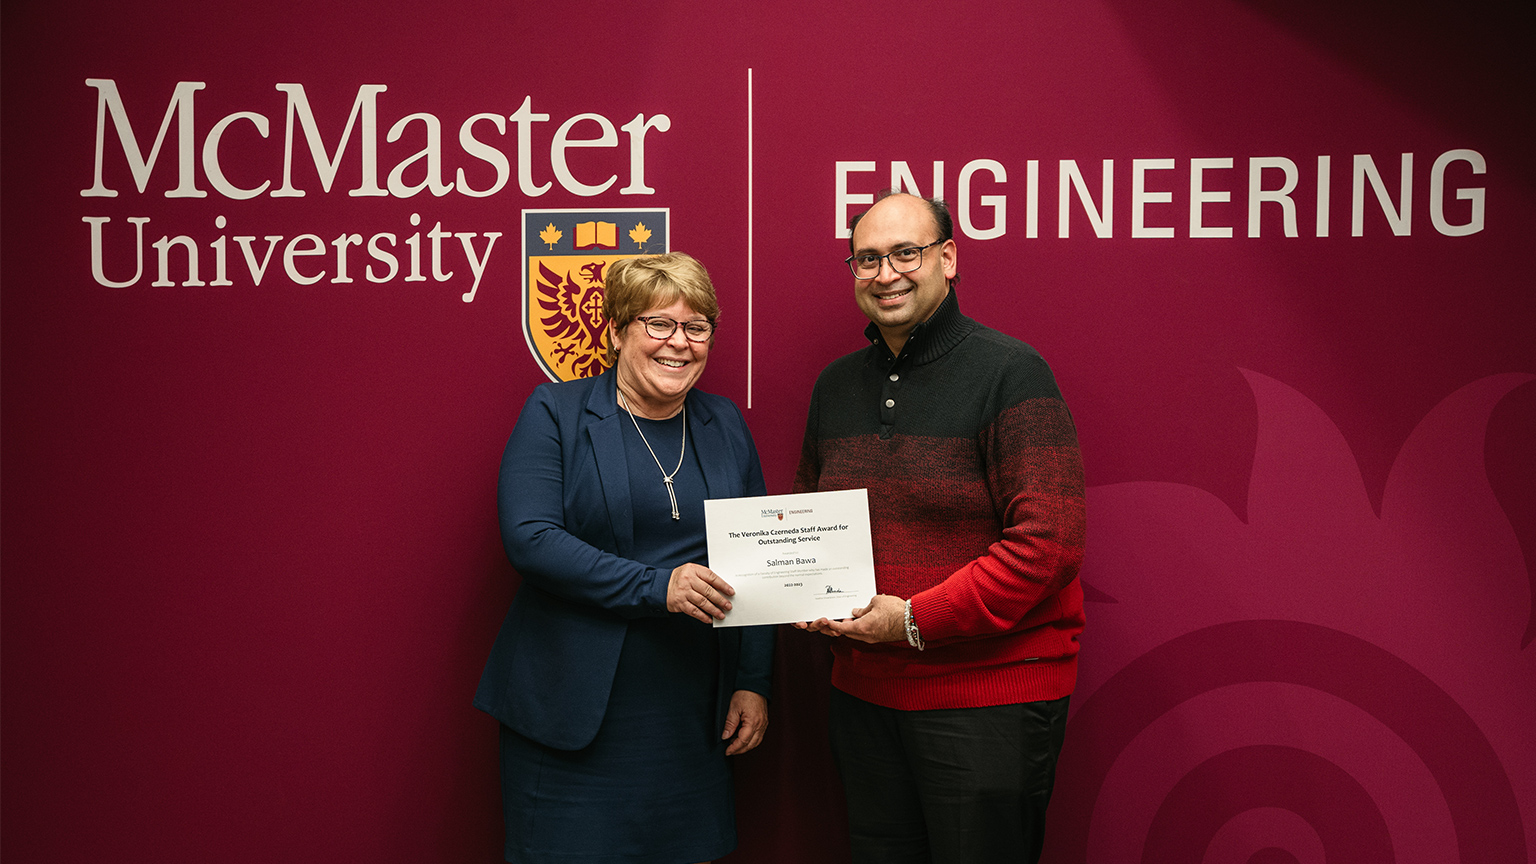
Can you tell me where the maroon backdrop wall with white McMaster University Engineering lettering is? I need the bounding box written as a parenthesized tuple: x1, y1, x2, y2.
(0, 0, 1536, 864)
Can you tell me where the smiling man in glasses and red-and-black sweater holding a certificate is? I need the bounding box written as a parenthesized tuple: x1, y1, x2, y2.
(794, 194, 1083, 864)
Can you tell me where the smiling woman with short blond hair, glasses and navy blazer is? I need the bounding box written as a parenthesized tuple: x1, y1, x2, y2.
(475, 252, 773, 864)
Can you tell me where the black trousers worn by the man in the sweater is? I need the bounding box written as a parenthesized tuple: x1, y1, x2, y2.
(829, 687, 1068, 864)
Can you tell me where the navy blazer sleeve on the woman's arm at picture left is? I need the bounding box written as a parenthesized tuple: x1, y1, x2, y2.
(496, 386, 671, 618)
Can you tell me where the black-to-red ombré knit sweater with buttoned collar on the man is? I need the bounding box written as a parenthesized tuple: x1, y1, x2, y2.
(794, 291, 1084, 710)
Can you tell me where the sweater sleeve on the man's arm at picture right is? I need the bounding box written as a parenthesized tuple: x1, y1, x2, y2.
(912, 361, 1086, 640)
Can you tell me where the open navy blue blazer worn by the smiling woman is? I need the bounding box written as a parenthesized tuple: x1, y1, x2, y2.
(475, 369, 774, 750)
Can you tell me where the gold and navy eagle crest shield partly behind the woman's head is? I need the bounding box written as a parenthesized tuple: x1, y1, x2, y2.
(521, 208, 670, 381)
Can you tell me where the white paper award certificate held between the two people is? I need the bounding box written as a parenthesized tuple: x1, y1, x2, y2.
(703, 489, 876, 627)
